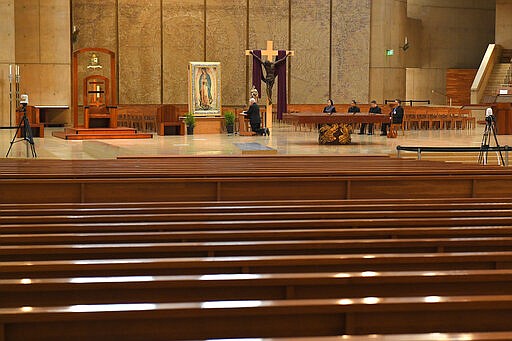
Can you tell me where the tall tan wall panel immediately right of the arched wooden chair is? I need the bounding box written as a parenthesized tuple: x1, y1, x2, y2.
(118, 0, 161, 104)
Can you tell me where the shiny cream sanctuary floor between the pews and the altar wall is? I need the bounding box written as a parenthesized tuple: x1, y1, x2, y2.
(0, 125, 512, 160)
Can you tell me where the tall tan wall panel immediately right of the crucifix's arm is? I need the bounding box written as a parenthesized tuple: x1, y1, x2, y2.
(288, 0, 330, 104)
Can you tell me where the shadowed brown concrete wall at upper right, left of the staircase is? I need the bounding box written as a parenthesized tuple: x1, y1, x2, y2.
(407, 0, 499, 104)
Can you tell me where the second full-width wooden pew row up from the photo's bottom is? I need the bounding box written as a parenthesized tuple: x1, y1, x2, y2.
(0, 270, 512, 308)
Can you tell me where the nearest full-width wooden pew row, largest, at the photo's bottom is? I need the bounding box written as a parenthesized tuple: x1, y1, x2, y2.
(0, 296, 512, 341)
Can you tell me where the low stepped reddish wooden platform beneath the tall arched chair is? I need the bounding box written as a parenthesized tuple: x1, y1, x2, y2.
(52, 128, 153, 140)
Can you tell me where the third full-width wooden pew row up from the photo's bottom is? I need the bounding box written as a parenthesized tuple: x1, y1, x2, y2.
(0, 252, 512, 279)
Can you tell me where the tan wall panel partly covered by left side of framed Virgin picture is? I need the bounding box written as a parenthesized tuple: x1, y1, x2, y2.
(162, 0, 205, 104)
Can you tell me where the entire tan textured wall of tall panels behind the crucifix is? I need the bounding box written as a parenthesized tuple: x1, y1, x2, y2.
(72, 0, 371, 105)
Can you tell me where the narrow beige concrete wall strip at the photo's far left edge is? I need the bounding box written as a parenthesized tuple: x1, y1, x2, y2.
(0, 0, 15, 126)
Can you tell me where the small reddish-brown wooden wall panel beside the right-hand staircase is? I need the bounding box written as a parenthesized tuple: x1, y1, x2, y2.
(446, 69, 478, 105)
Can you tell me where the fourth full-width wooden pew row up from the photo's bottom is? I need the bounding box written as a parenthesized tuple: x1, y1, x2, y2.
(5, 237, 512, 262)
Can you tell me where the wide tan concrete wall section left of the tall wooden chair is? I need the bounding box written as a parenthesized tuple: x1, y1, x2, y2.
(14, 0, 71, 122)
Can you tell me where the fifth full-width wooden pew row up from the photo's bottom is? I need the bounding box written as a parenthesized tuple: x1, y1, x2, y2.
(5, 226, 512, 246)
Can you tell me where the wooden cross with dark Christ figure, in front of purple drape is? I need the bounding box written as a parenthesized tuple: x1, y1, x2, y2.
(245, 40, 295, 128)
